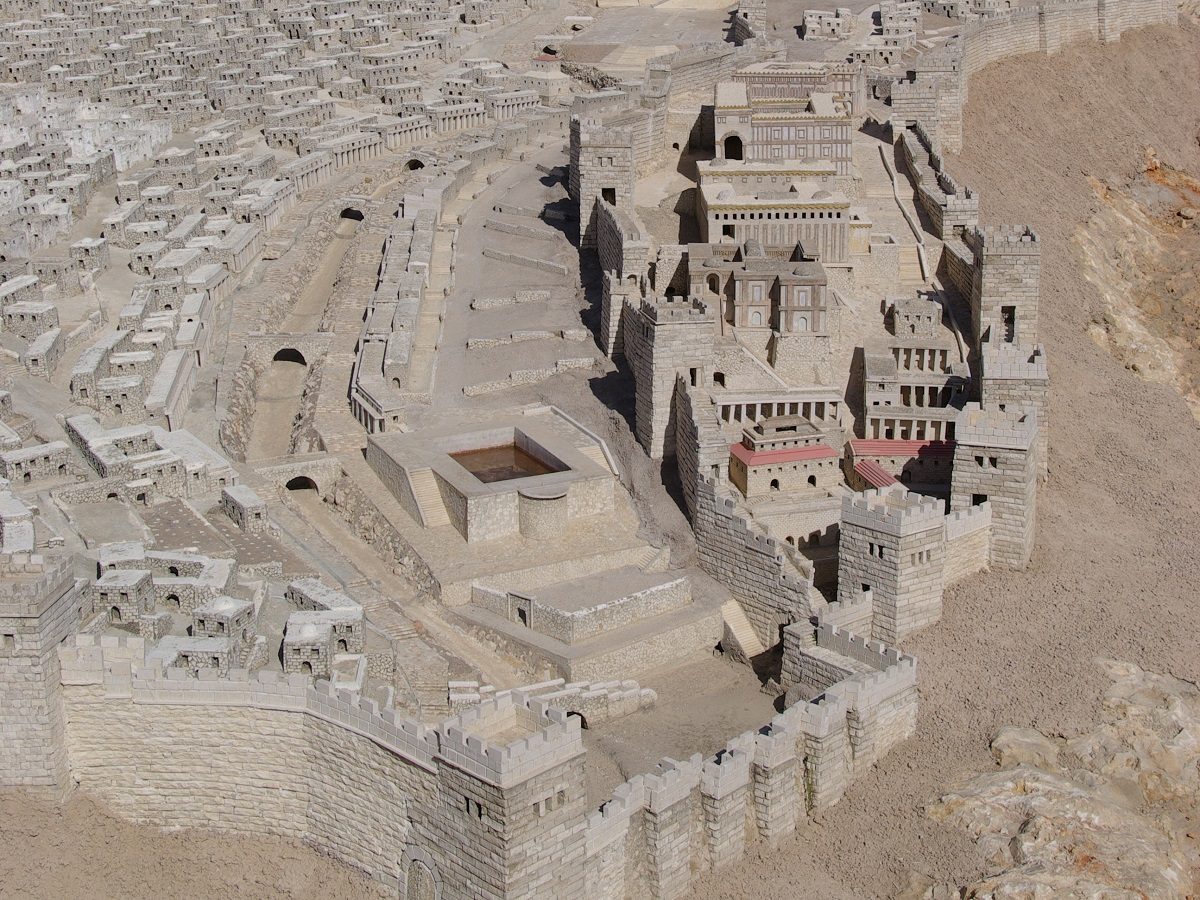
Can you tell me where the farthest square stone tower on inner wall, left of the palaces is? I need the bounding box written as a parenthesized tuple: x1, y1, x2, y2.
(568, 116, 635, 247)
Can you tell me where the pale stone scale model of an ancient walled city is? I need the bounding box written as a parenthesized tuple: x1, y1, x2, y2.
(0, 0, 1200, 899)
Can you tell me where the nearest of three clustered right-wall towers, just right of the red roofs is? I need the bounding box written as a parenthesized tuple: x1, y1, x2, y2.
(950, 403, 1038, 569)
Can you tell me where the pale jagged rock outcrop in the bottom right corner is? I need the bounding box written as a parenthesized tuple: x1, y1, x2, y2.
(926, 661, 1200, 900)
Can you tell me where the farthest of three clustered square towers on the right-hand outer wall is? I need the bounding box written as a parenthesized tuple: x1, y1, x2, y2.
(962, 226, 1042, 349)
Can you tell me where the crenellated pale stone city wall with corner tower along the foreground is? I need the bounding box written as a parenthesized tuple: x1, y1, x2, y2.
(51, 588, 916, 898)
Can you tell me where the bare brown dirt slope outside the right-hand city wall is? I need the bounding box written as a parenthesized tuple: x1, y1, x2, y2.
(697, 24, 1200, 898)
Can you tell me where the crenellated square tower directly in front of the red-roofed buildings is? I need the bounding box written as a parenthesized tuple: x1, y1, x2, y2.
(838, 485, 946, 643)
